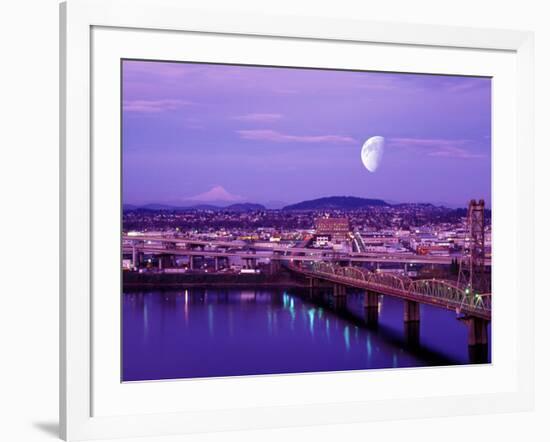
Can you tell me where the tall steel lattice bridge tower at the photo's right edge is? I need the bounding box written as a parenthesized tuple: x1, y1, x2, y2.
(458, 200, 490, 294)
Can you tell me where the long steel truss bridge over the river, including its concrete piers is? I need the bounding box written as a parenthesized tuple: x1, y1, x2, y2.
(287, 262, 491, 346)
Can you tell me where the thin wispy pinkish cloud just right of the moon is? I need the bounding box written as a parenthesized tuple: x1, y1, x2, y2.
(388, 138, 486, 159)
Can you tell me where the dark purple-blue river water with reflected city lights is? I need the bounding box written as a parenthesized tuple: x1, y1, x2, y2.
(122, 289, 492, 381)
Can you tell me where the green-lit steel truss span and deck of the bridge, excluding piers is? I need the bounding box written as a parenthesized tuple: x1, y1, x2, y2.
(288, 262, 491, 321)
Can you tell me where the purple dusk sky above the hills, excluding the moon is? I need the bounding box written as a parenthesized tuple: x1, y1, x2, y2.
(122, 61, 491, 206)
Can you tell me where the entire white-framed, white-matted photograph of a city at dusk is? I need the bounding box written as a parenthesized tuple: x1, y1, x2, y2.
(60, 0, 533, 440)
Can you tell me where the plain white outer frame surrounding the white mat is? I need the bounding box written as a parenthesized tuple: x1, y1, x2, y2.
(60, 0, 534, 440)
